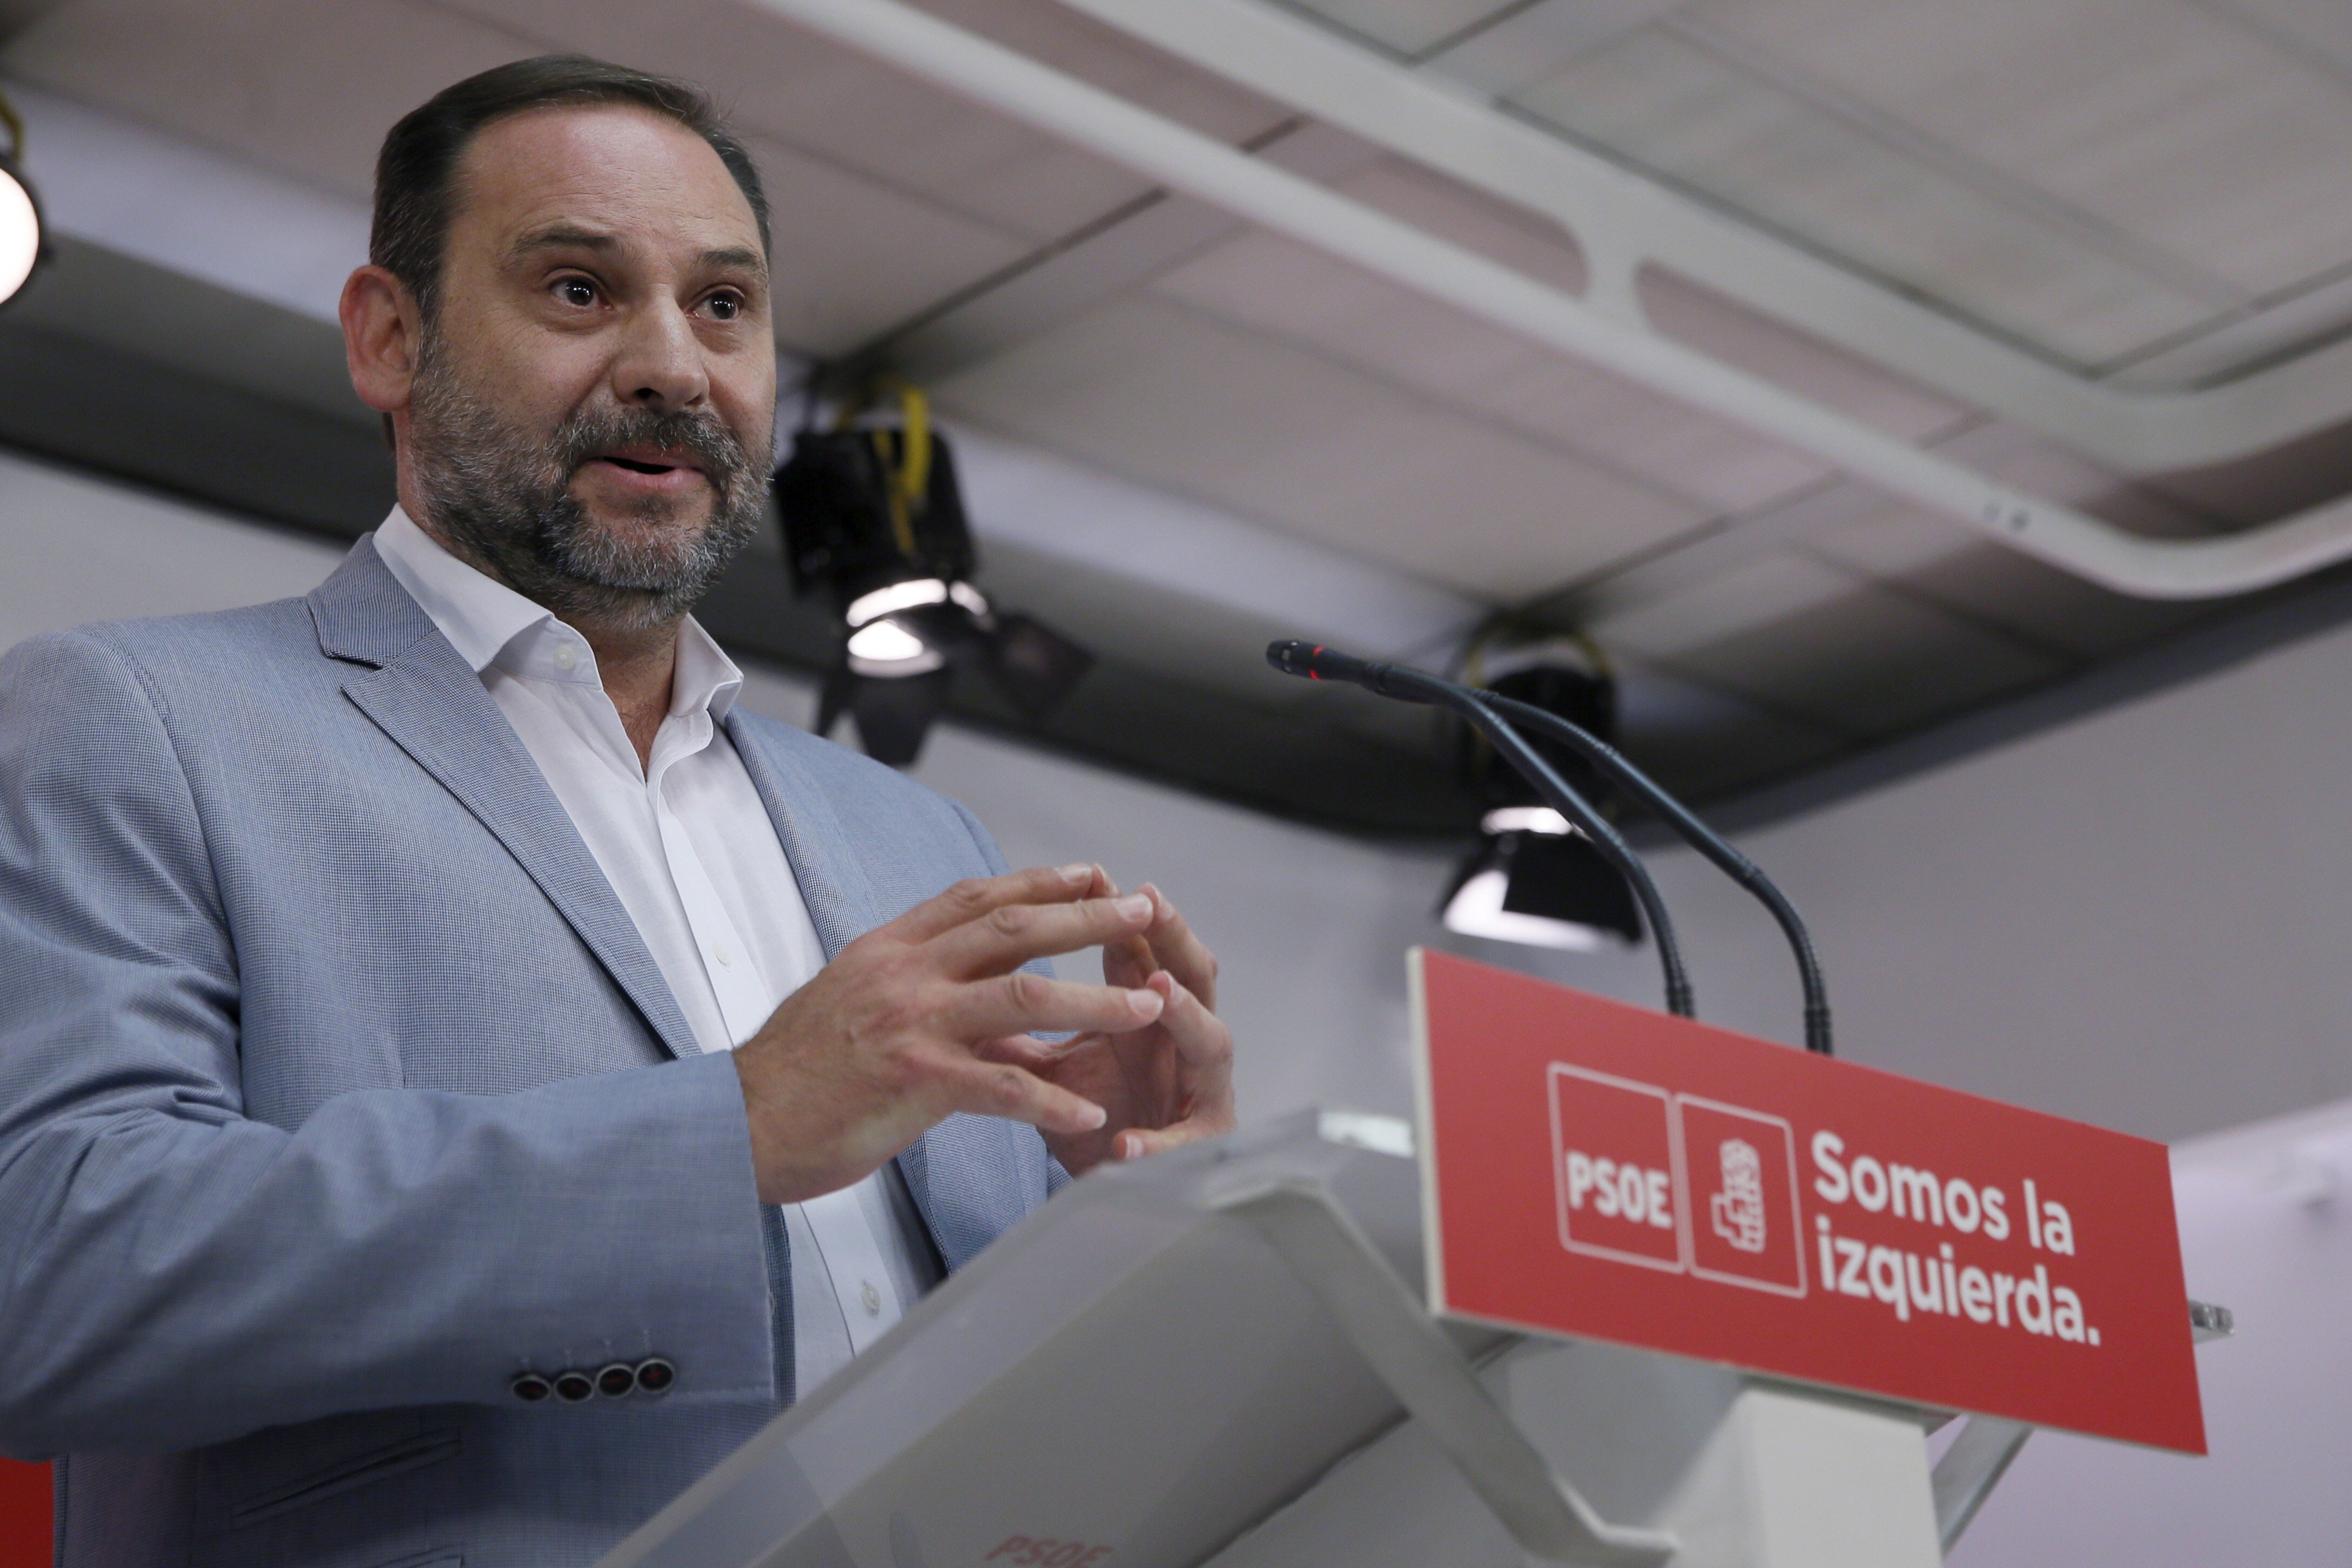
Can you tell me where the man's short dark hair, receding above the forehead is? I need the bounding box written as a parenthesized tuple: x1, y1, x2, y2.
(367, 54, 769, 318)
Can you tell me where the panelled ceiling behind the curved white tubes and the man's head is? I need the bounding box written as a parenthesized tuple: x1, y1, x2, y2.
(0, 0, 2352, 832)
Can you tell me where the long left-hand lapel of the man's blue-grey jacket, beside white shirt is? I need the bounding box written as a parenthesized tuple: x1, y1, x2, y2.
(311, 539, 698, 1055)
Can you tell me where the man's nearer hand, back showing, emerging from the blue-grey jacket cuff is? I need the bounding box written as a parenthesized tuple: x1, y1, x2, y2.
(734, 865, 1171, 1203)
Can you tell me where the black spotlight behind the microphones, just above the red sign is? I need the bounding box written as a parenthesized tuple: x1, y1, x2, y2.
(1440, 640, 1642, 952)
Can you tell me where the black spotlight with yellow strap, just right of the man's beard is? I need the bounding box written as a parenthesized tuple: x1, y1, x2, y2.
(776, 386, 1094, 769)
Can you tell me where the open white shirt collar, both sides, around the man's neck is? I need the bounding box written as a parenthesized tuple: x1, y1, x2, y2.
(377, 506, 743, 719)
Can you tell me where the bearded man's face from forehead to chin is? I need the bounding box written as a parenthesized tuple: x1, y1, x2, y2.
(409, 106, 776, 625)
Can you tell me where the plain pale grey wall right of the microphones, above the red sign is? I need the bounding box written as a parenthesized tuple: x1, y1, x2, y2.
(1543, 606, 2352, 1138)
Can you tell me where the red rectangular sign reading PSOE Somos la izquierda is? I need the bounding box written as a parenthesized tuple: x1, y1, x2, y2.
(1411, 950, 2204, 1453)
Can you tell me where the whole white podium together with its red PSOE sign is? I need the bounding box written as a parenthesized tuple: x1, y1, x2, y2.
(602, 959, 2201, 1568)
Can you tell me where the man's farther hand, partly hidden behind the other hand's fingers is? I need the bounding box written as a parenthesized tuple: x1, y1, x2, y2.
(981, 867, 1232, 1175)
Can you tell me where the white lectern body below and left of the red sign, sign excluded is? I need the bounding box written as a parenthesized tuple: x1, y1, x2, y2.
(604, 1112, 2079, 1568)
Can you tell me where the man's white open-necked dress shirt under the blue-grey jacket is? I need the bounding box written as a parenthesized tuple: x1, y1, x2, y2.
(377, 506, 938, 1394)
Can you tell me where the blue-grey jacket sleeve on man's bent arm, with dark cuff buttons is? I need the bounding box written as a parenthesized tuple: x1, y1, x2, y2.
(0, 635, 774, 1457)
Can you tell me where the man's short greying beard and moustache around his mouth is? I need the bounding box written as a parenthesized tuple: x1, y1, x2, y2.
(409, 329, 767, 632)
